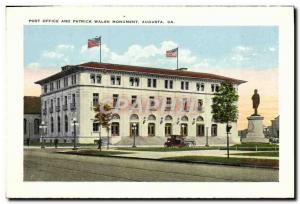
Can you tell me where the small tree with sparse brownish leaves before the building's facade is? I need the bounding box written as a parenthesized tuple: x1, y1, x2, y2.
(94, 104, 112, 149)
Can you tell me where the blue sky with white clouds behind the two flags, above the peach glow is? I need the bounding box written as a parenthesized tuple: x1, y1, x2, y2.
(24, 25, 278, 70)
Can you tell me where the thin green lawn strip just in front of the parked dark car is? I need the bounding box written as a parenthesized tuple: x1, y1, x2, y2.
(116, 147, 220, 152)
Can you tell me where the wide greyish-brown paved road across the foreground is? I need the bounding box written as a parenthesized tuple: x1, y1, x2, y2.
(24, 149, 279, 182)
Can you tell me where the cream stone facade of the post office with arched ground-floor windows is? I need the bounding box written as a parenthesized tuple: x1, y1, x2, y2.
(36, 63, 243, 145)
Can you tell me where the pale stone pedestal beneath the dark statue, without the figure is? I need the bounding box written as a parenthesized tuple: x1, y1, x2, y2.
(242, 116, 269, 143)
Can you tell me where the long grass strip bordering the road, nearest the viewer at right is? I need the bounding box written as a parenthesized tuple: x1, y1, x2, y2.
(163, 156, 279, 168)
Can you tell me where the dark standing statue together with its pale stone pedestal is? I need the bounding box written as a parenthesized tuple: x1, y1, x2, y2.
(242, 89, 269, 143)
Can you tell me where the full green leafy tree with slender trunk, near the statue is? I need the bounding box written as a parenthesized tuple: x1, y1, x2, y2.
(211, 82, 239, 158)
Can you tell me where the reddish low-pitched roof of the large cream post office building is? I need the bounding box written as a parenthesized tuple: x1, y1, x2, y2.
(36, 62, 246, 84)
